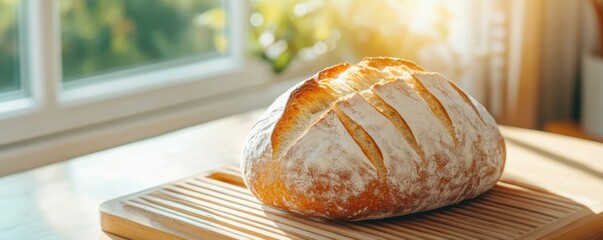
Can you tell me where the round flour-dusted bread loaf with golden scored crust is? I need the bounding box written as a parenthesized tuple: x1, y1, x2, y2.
(241, 57, 505, 220)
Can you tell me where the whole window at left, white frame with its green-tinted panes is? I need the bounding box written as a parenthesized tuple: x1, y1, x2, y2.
(0, 0, 248, 148)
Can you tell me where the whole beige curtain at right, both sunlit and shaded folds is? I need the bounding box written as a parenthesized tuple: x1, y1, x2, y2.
(490, 0, 582, 128)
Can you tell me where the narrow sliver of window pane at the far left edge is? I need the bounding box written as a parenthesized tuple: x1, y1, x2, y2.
(0, 0, 21, 94)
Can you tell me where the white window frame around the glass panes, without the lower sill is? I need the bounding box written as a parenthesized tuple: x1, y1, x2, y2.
(0, 0, 255, 146)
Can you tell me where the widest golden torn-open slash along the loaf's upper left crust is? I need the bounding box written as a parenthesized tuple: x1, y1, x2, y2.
(272, 57, 430, 158)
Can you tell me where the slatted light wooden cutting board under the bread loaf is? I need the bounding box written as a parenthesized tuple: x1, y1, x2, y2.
(100, 167, 596, 239)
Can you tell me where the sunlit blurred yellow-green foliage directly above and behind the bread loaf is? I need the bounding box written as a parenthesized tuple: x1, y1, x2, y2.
(245, 0, 455, 72)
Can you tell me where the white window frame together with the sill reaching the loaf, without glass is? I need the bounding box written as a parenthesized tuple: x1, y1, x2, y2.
(0, 0, 333, 176)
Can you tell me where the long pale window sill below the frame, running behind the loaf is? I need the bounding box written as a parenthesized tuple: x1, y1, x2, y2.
(0, 78, 304, 176)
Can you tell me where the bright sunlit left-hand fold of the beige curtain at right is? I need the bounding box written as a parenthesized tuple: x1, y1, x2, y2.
(499, 0, 544, 128)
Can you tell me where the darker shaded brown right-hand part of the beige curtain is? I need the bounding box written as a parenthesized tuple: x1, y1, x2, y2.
(538, 0, 585, 126)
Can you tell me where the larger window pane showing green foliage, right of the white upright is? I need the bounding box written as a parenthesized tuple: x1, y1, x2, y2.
(61, 0, 226, 82)
